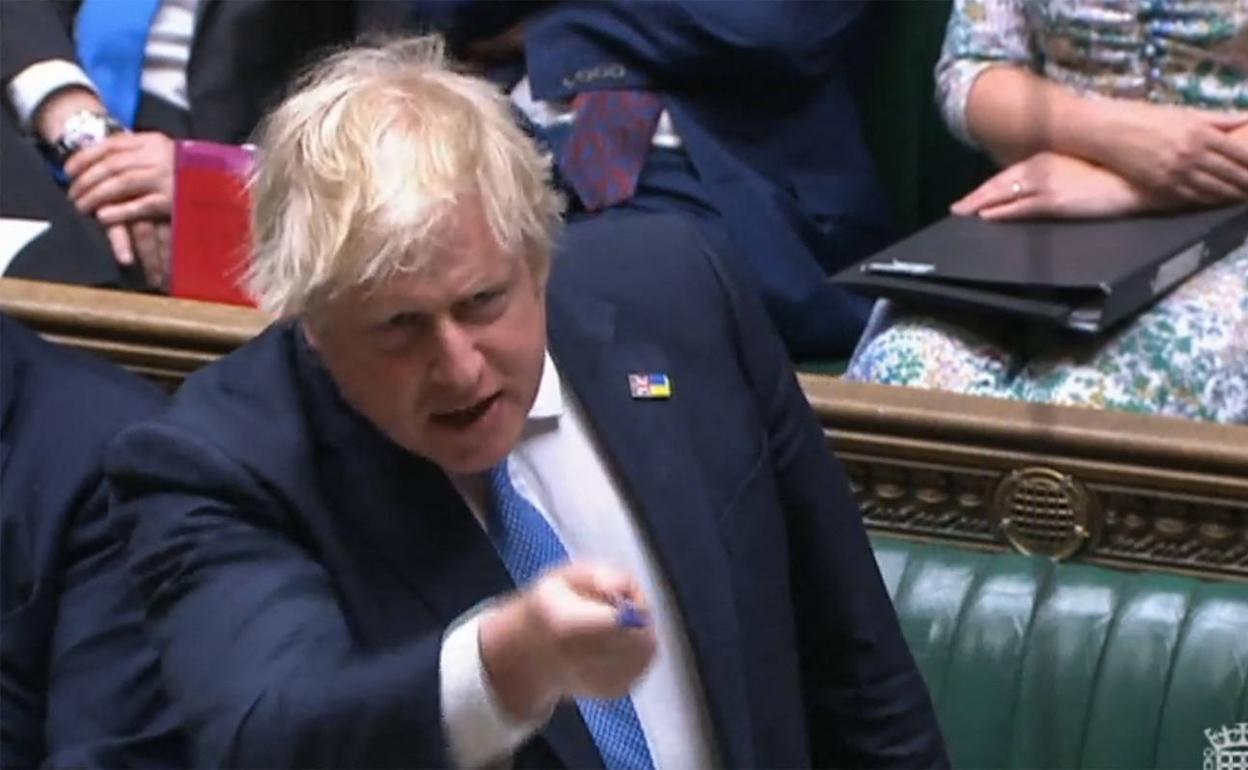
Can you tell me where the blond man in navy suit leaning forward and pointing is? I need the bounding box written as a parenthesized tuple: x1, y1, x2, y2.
(109, 37, 946, 769)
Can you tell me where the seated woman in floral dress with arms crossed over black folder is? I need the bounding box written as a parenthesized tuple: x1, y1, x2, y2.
(847, 0, 1248, 423)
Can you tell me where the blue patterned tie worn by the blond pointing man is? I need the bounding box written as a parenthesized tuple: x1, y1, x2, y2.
(487, 461, 654, 770)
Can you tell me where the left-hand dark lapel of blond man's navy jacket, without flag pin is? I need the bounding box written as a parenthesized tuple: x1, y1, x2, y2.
(296, 331, 603, 768)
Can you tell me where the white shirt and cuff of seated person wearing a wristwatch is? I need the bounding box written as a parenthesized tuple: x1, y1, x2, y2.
(6, 0, 200, 131)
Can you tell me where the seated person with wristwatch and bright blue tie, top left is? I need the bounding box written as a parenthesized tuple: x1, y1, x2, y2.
(0, 0, 386, 287)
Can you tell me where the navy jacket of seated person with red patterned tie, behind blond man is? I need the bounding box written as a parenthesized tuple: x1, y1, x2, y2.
(413, 0, 890, 358)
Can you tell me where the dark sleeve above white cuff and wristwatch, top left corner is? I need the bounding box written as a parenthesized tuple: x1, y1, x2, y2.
(0, 0, 77, 86)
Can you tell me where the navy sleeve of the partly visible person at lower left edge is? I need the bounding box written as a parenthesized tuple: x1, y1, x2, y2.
(44, 477, 182, 768)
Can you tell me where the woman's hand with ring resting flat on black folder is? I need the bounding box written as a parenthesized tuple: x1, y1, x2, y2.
(950, 152, 1159, 220)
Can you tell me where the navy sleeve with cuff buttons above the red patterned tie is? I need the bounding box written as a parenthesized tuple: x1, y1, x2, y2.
(525, 0, 864, 99)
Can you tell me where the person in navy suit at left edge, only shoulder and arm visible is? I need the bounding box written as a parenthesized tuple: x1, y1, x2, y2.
(0, 316, 185, 768)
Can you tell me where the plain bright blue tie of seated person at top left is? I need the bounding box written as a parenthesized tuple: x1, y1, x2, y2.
(74, 0, 161, 129)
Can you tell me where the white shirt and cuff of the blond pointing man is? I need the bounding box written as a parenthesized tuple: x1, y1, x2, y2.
(441, 353, 718, 770)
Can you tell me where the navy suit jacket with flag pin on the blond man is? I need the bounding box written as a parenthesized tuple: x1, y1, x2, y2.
(109, 217, 946, 768)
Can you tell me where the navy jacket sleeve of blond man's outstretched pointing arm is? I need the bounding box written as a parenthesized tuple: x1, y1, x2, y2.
(110, 424, 451, 768)
